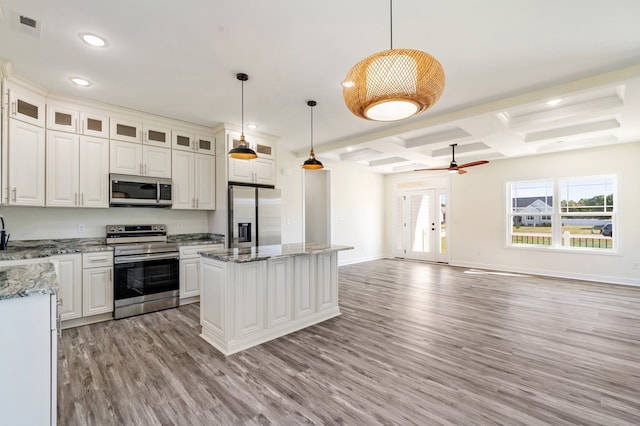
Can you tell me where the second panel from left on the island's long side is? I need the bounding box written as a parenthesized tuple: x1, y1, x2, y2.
(266, 257, 293, 328)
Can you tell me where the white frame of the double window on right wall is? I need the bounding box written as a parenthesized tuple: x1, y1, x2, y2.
(504, 174, 620, 255)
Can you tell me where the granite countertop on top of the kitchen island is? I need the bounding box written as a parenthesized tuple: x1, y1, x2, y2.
(200, 243, 353, 263)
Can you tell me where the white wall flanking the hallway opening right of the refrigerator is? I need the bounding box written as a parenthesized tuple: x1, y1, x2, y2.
(276, 150, 386, 264)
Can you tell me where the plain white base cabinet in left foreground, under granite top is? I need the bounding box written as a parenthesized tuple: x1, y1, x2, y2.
(0, 294, 58, 426)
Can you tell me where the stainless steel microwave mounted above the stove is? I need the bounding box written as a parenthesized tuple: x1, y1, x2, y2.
(109, 174, 171, 207)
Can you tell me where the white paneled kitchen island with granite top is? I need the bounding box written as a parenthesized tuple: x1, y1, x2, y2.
(200, 244, 353, 355)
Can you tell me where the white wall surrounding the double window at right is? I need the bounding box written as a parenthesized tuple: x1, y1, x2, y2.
(448, 143, 640, 285)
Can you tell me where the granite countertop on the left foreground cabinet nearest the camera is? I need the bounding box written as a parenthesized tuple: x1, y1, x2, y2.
(0, 262, 58, 300)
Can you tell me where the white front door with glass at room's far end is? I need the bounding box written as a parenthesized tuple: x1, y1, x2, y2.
(394, 189, 445, 262)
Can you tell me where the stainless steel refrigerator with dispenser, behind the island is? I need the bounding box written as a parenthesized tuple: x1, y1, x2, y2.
(229, 185, 282, 248)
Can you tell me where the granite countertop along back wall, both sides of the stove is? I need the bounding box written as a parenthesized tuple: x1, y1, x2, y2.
(0, 234, 224, 261)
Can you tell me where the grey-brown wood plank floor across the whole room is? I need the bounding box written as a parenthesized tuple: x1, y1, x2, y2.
(58, 259, 640, 425)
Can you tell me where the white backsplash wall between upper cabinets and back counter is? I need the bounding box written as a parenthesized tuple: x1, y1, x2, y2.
(0, 206, 208, 241)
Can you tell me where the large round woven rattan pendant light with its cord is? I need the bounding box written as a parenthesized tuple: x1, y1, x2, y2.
(342, 0, 444, 121)
